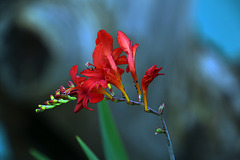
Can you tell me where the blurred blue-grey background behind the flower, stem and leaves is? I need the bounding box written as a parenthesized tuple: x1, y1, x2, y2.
(0, 0, 240, 160)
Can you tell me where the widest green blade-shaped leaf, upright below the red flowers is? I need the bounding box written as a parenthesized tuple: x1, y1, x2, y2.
(98, 101, 129, 160)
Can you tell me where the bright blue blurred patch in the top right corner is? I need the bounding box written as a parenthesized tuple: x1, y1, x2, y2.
(194, 0, 240, 60)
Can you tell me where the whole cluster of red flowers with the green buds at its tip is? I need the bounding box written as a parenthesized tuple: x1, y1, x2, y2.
(36, 30, 163, 113)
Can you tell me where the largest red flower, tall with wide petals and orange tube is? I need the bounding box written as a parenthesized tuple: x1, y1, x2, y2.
(81, 30, 129, 102)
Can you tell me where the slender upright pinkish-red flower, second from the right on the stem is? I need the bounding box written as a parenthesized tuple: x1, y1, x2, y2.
(117, 31, 141, 101)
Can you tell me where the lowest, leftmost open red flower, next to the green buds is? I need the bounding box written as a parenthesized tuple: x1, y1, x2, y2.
(66, 65, 111, 113)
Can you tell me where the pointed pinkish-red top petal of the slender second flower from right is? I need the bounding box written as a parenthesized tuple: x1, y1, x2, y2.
(117, 31, 131, 54)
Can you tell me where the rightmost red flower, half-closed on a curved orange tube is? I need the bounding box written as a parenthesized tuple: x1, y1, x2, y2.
(142, 65, 164, 111)
